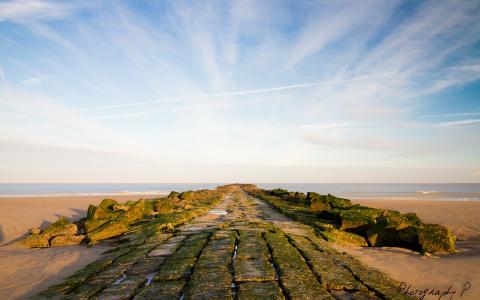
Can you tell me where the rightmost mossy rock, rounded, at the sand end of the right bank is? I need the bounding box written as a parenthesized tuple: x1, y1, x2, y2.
(418, 224, 455, 253)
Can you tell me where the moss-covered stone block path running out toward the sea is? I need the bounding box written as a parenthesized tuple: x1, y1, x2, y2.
(35, 190, 412, 299)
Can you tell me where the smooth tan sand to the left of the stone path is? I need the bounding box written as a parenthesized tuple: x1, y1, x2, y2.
(0, 195, 159, 300)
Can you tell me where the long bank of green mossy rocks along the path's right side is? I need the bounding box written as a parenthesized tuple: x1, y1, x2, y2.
(248, 189, 455, 253)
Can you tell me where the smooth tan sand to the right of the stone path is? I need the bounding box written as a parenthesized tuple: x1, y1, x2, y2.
(338, 199, 480, 300)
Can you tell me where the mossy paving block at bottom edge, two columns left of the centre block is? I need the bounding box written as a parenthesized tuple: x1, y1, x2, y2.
(133, 280, 186, 300)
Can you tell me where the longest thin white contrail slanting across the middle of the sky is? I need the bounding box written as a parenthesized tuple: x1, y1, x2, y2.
(70, 75, 372, 112)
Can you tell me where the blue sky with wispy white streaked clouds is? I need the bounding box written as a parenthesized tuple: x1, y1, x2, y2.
(0, 0, 480, 183)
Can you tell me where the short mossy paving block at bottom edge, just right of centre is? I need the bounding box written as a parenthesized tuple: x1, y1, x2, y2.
(238, 281, 285, 300)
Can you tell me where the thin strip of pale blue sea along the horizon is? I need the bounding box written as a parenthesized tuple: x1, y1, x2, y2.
(0, 183, 480, 201)
